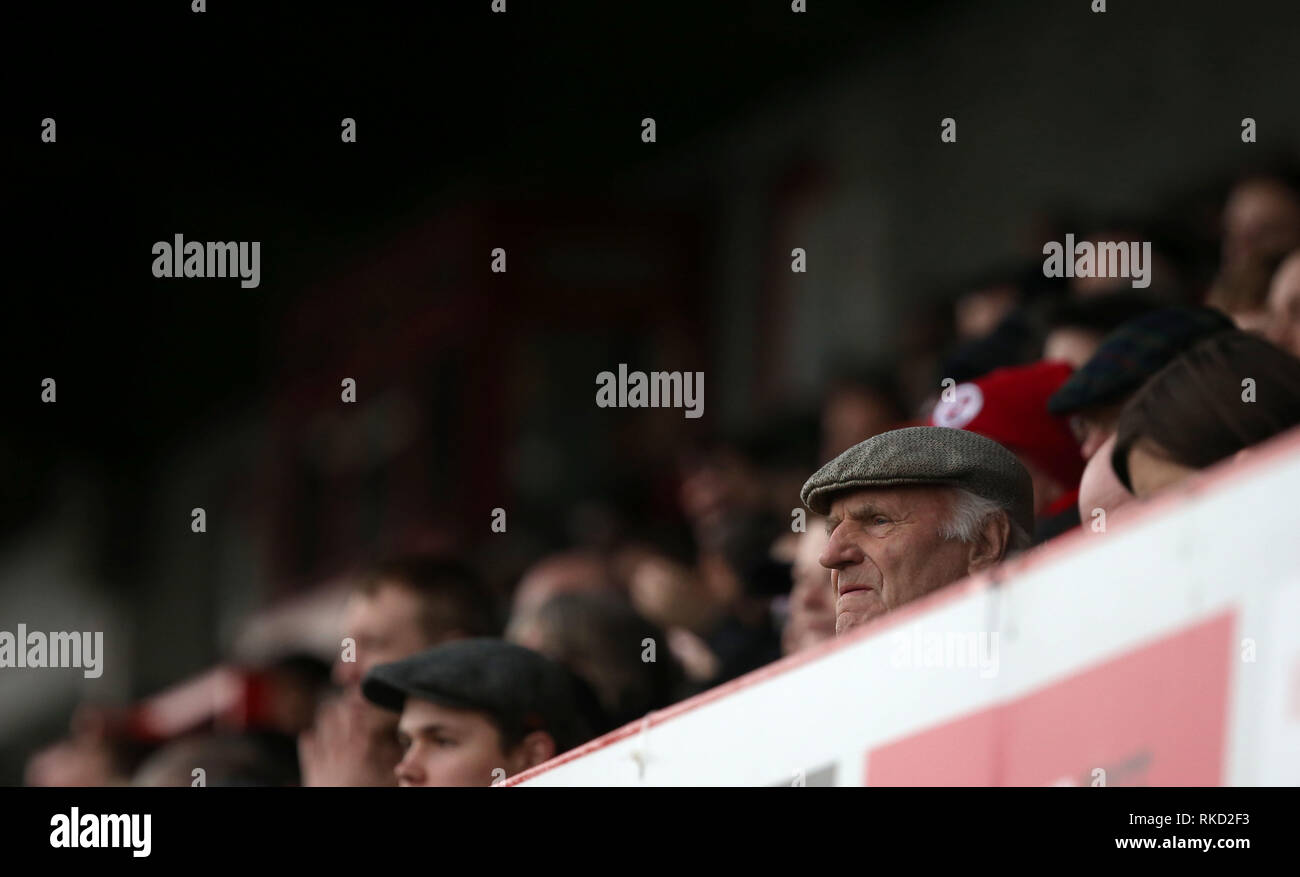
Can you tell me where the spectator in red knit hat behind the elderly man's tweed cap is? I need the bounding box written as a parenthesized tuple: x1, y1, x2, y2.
(930, 362, 1083, 540)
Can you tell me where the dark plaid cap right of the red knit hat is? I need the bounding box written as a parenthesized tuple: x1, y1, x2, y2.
(1048, 305, 1236, 416)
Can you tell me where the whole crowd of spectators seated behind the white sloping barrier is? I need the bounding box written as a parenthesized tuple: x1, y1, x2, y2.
(27, 166, 1300, 786)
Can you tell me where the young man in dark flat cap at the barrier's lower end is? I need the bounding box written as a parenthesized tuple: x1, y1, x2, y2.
(361, 638, 606, 786)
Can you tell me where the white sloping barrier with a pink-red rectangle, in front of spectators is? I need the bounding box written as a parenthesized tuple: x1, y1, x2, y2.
(507, 433, 1300, 786)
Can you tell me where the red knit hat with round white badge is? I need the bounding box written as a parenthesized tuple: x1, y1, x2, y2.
(930, 361, 1084, 491)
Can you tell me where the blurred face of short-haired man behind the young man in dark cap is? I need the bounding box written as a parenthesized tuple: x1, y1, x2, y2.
(334, 582, 433, 687)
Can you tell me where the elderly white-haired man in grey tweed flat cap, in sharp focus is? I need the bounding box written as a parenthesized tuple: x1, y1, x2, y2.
(800, 426, 1034, 635)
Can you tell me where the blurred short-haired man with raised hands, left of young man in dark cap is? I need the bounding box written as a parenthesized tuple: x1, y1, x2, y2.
(299, 556, 499, 786)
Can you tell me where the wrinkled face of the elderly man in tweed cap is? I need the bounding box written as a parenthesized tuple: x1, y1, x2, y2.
(820, 487, 970, 635)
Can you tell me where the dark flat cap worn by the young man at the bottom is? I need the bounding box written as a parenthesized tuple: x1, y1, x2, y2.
(361, 638, 606, 752)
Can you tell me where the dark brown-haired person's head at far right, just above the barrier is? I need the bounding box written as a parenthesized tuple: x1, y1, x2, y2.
(1110, 330, 1300, 498)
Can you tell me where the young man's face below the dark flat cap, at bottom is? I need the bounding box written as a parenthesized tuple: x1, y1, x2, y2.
(394, 698, 555, 786)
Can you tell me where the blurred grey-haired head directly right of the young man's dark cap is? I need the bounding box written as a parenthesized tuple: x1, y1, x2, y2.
(507, 592, 681, 726)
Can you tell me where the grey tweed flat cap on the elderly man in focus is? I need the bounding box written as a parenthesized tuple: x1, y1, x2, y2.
(800, 426, 1034, 533)
